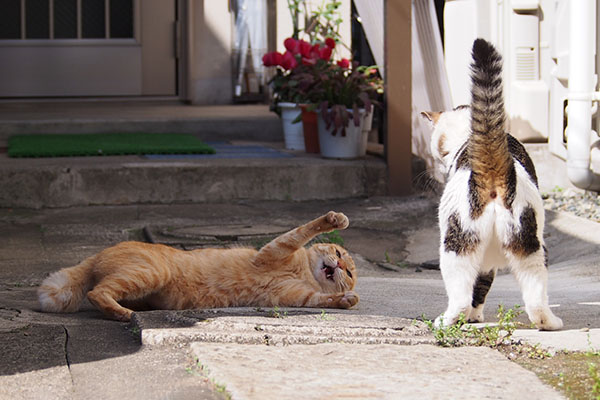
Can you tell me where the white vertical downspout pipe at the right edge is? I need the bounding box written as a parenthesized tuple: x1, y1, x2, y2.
(566, 0, 600, 191)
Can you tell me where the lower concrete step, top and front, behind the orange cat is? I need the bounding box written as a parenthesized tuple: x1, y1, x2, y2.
(0, 142, 387, 208)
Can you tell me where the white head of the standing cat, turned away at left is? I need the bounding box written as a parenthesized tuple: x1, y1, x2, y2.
(421, 106, 471, 167)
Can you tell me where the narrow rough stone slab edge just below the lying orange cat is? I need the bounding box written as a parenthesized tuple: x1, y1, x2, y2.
(132, 308, 434, 346)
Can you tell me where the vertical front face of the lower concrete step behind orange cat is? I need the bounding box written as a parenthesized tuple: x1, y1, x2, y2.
(0, 162, 387, 208)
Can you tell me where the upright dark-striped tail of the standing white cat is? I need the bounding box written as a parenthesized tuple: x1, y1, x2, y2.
(468, 39, 514, 211)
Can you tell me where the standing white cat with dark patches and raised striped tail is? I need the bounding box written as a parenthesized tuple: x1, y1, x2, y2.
(423, 39, 562, 330)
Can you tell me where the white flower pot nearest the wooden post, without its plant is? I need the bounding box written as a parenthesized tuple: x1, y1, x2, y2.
(318, 109, 372, 159)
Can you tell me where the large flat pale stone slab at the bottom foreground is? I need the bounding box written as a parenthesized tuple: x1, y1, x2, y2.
(191, 343, 563, 400)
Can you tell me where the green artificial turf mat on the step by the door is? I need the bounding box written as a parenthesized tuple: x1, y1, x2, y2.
(8, 133, 215, 157)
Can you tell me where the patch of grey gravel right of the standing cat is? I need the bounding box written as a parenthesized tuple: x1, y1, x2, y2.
(542, 188, 600, 222)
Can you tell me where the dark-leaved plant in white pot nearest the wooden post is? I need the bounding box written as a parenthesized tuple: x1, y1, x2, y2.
(298, 55, 383, 158)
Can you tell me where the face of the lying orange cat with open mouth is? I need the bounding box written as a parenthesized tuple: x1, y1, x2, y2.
(311, 243, 356, 293)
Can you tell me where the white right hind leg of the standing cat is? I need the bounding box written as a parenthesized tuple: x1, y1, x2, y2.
(511, 253, 563, 331)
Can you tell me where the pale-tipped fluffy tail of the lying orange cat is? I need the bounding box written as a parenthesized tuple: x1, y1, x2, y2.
(37, 256, 95, 312)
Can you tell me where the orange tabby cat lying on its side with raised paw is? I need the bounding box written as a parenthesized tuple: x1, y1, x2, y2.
(38, 211, 359, 321)
